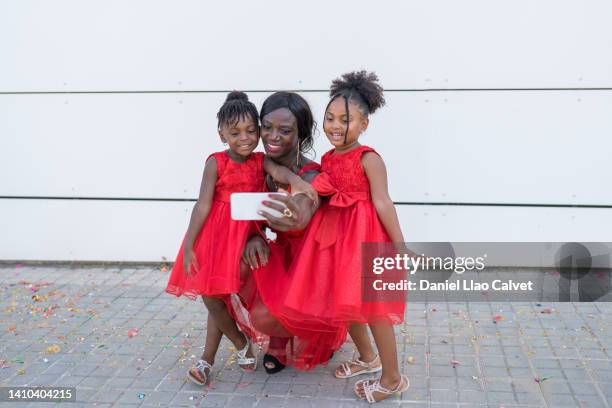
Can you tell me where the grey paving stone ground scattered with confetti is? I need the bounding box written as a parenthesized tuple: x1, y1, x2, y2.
(0, 264, 612, 408)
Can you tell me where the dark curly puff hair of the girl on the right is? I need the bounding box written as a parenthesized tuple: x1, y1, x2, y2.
(325, 71, 385, 116)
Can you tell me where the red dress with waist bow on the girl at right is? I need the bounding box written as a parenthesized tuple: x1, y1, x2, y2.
(274, 146, 406, 330)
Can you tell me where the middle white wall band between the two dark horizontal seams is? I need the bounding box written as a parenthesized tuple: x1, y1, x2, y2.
(0, 91, 612, 205)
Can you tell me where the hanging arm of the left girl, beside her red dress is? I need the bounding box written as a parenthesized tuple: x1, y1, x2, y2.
(183, 157, 217, 276)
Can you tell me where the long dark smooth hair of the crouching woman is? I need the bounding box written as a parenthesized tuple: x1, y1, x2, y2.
(259, 92, 317, 153)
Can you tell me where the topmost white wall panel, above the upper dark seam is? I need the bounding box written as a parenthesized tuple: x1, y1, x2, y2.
(0, 0, 612, 91)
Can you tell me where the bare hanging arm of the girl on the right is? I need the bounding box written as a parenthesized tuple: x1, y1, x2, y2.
(361, 152, 404, 249)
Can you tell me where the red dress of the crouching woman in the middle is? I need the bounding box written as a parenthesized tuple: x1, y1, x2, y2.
(230, 162, 346, 370)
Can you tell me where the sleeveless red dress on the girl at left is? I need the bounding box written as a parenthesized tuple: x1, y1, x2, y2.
(166, 151, 264, 299)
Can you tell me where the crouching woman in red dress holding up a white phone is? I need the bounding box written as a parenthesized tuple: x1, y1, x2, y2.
(231, 92, 346, 373)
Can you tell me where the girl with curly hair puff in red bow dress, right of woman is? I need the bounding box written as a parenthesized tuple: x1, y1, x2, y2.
(276, 71, 409, 402)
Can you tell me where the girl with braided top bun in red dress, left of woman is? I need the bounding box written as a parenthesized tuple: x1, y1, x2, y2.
(166, 91, 316, 385)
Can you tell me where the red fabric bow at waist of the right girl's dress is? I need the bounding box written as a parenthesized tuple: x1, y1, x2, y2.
(312, 172, 370, 249)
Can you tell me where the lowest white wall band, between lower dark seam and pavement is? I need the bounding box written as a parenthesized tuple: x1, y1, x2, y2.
(0, 199, 612, 261)
